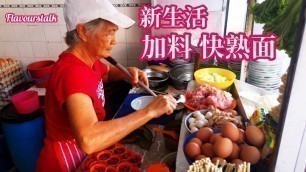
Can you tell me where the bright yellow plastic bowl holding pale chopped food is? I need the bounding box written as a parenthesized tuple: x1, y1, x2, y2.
(194, 68, 236, 90)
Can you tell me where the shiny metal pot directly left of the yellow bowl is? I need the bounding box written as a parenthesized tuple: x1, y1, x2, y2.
(169, 63, 194, 90)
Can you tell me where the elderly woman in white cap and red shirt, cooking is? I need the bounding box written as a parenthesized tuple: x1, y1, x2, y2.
(37, 0, 176, 171)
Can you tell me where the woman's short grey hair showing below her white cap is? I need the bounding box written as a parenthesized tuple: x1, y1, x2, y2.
(65, 18, 106, 47)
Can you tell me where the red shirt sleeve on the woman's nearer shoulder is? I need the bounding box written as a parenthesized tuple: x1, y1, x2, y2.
(55, 66, 93, 107)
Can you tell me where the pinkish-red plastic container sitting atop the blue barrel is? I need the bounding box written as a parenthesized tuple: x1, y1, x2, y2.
(11, 90, 40, 114)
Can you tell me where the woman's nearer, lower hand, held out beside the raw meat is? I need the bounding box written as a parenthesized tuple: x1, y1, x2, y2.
(145, 94, 177, 118)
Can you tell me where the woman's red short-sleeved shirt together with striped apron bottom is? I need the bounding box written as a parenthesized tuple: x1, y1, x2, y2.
(37, 53, 108, 171)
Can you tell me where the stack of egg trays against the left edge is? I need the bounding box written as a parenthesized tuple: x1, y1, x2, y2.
(0, 58, 25, 109)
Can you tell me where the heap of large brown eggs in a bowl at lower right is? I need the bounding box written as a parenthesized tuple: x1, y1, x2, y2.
(183, 123, 265, 169)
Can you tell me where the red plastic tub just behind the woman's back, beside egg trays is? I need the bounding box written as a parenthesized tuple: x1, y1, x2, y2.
(27, 60, 55, 88)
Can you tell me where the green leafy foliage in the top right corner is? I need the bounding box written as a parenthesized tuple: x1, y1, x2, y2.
(252, 0, 302, 57)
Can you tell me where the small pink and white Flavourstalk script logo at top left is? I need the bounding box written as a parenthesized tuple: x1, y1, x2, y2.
(5, 13, 58, 23)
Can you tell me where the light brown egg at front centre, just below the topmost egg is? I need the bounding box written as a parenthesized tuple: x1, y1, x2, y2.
(214, 138, 233, 158)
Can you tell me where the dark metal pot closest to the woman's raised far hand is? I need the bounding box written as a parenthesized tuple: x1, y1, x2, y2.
(143, 69, 169, 91)
